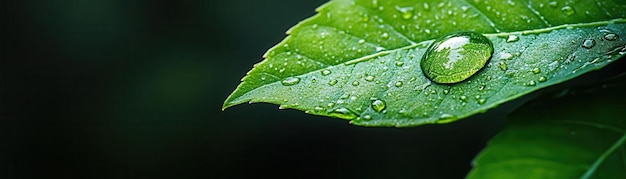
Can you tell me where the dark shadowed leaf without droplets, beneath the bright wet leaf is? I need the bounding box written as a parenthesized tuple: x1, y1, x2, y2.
(468, 78, 626, 178)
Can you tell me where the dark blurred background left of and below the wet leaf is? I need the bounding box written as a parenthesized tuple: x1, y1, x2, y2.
(0, 0, 502, 178)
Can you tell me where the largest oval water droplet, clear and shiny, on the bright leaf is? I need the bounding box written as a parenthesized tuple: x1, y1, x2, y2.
(420, 32, 493, 84)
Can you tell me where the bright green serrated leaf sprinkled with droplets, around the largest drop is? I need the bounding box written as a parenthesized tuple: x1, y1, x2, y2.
(223, 0, 626, 126)
